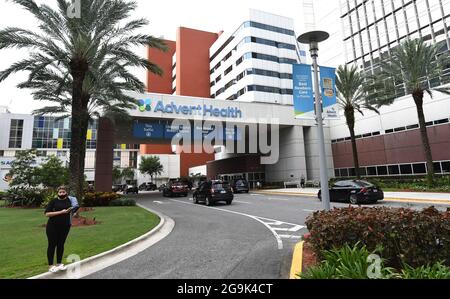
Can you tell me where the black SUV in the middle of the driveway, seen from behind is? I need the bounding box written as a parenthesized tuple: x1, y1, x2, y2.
(193, 181, 234, 206)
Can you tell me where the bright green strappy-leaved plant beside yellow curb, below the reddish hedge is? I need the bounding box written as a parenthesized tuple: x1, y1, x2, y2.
(301, 243, 393, 279)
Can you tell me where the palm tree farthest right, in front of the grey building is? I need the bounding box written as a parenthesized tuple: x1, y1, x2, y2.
(373, 39, 450, 187)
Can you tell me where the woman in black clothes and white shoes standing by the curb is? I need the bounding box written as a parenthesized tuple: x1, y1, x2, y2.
(45, 186, 77, 273)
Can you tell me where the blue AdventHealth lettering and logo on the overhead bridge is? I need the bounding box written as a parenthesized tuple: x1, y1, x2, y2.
(139, 99, 242, 118)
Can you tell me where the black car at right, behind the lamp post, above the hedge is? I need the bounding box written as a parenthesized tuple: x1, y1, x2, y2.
(318, 180, 384, 205)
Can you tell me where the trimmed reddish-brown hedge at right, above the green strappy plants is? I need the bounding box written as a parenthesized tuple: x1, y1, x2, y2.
(306, 207, 450, 269)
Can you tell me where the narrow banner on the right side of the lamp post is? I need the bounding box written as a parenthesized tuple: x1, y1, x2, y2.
(320, 66, 339, 118)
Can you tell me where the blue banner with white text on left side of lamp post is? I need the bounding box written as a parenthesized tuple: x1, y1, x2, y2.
(293, 64, 314, 116)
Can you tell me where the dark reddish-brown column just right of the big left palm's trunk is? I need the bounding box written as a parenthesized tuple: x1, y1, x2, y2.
(95, 118, 114, 192)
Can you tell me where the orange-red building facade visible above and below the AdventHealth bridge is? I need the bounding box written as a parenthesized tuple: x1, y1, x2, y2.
(140, 27, 220, 176)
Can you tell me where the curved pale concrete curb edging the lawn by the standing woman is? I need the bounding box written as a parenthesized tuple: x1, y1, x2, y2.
(28, 204, 175, 279)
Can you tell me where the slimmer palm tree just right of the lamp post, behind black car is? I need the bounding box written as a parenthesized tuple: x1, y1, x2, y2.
(336, 65, 379, 179)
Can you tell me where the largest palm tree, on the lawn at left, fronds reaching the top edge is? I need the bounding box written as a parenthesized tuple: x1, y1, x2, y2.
(0, 0, 167, 202)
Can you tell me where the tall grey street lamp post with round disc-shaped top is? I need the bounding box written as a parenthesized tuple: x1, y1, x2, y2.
(298, 31, 330, 211)
